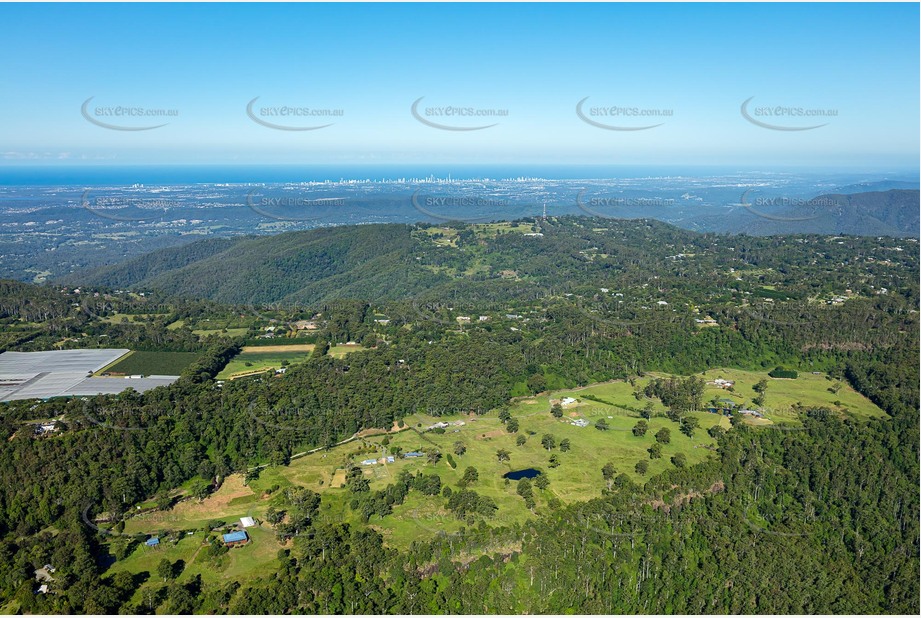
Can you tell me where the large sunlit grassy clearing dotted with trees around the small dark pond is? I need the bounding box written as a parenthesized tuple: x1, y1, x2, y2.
(104, 369, 882, 560)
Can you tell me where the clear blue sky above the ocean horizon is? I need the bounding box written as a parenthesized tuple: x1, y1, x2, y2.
(0, 4, 919, 169)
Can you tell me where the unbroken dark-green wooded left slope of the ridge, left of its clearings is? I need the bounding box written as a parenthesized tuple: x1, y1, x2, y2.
(69, 225, 425, 304)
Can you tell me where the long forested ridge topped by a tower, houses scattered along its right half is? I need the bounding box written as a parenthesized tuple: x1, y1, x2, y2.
(69, 216, 917, 304)
